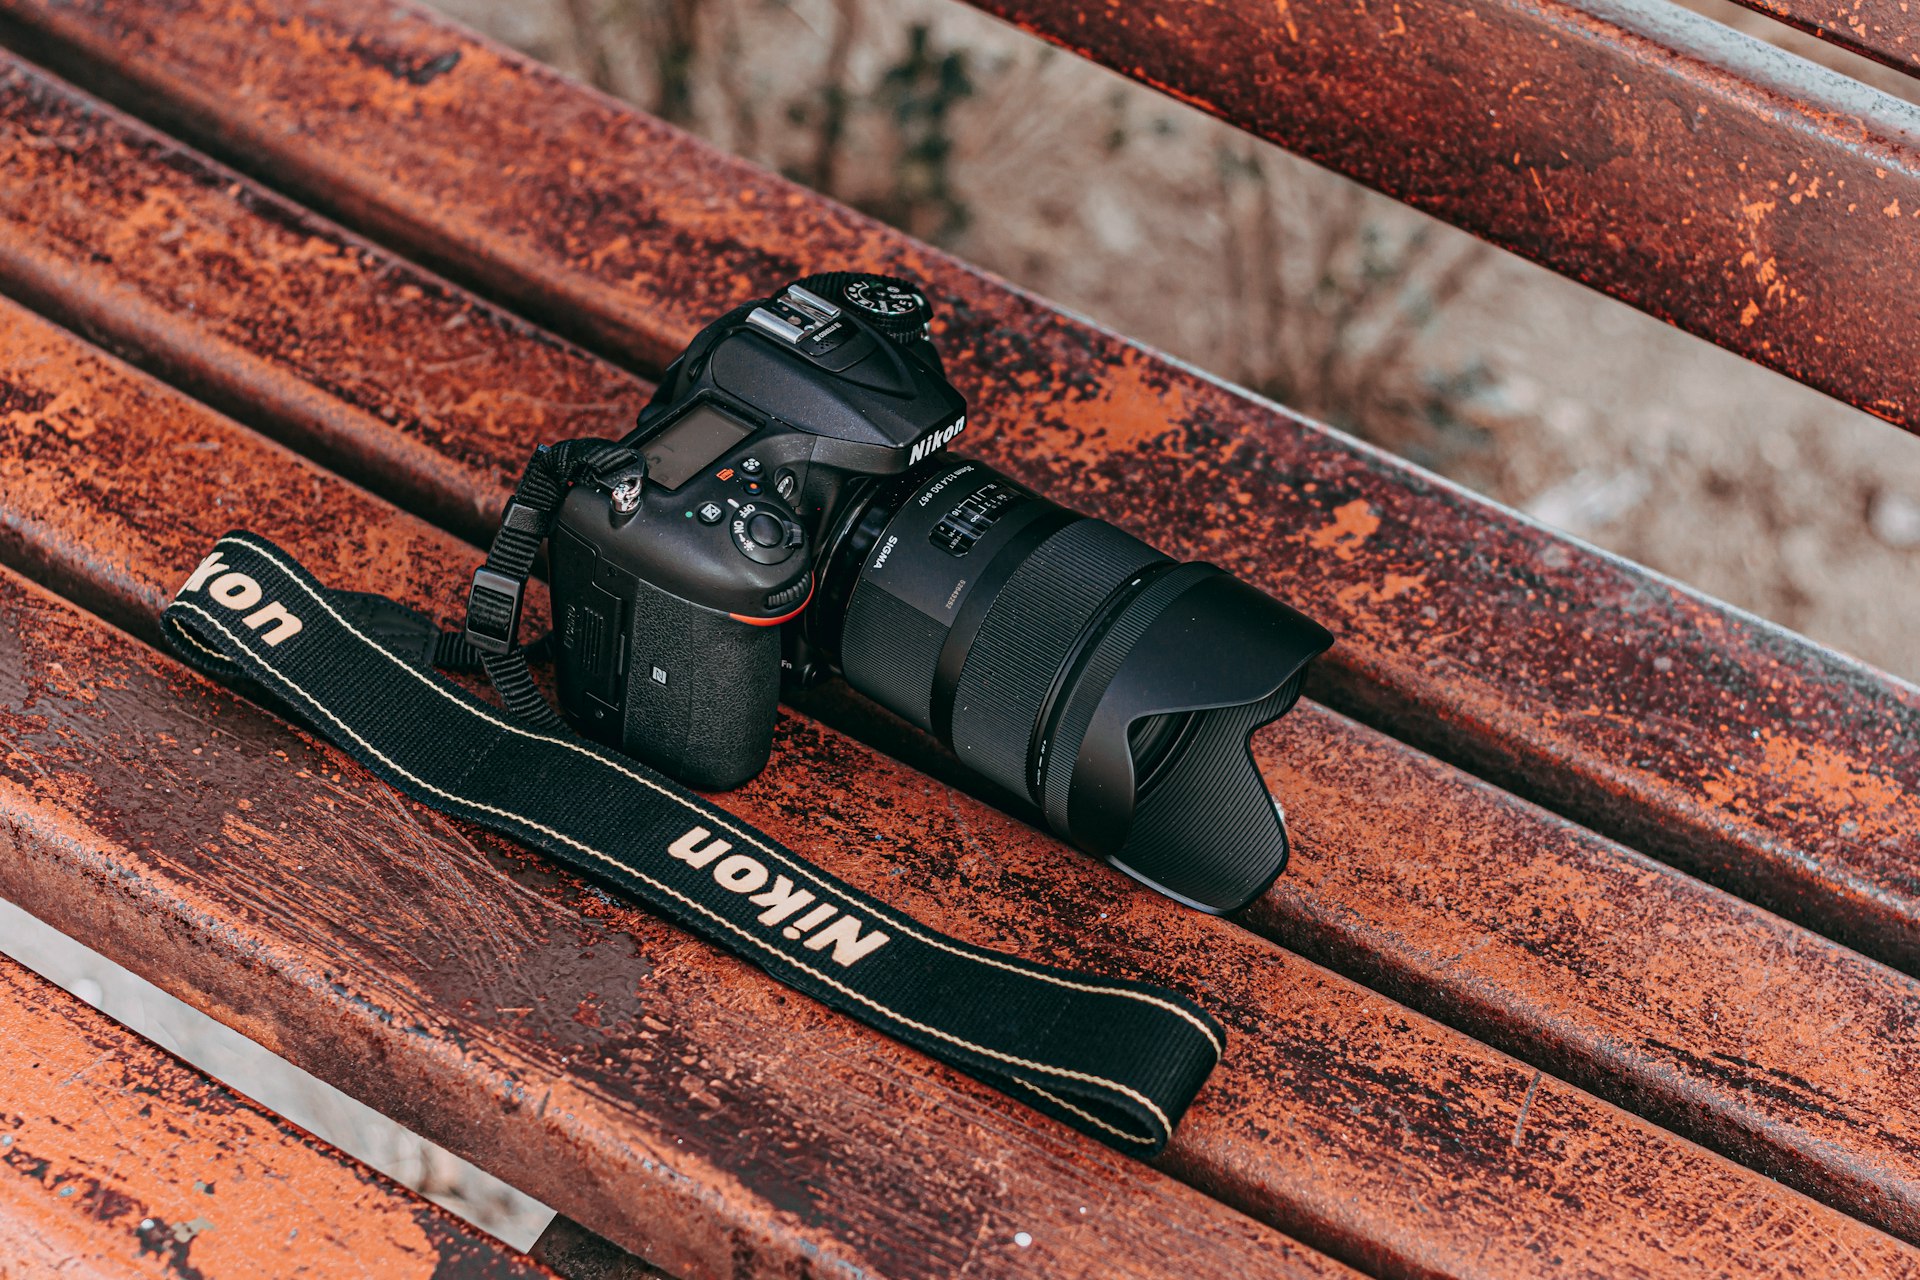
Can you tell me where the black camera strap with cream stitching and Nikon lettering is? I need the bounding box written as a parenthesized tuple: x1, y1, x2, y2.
(161, 525, 1225, 1157)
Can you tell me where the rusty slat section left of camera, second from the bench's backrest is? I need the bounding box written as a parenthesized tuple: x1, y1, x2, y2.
(0, 54, 637, 535)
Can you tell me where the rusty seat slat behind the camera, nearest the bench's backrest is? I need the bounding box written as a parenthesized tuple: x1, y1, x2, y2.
(0, 0, 1920, 973)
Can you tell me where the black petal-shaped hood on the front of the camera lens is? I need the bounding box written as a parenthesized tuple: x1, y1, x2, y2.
(1043, 564, 1332, 912)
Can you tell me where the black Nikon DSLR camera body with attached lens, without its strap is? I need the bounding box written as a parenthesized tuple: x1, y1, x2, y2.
(549, 273, 1332, 912)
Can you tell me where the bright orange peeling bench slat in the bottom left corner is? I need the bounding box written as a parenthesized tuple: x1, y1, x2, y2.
(0, 956, 555, 1280)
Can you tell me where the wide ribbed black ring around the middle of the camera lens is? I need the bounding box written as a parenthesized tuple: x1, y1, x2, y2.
(952, 520, 1167, 800)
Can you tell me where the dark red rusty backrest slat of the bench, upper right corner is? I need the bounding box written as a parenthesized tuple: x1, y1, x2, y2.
(975, 0, 1920, 416)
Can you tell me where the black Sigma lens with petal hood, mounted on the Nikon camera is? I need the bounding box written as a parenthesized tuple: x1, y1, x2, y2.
(810, 455, 1332, 912)
